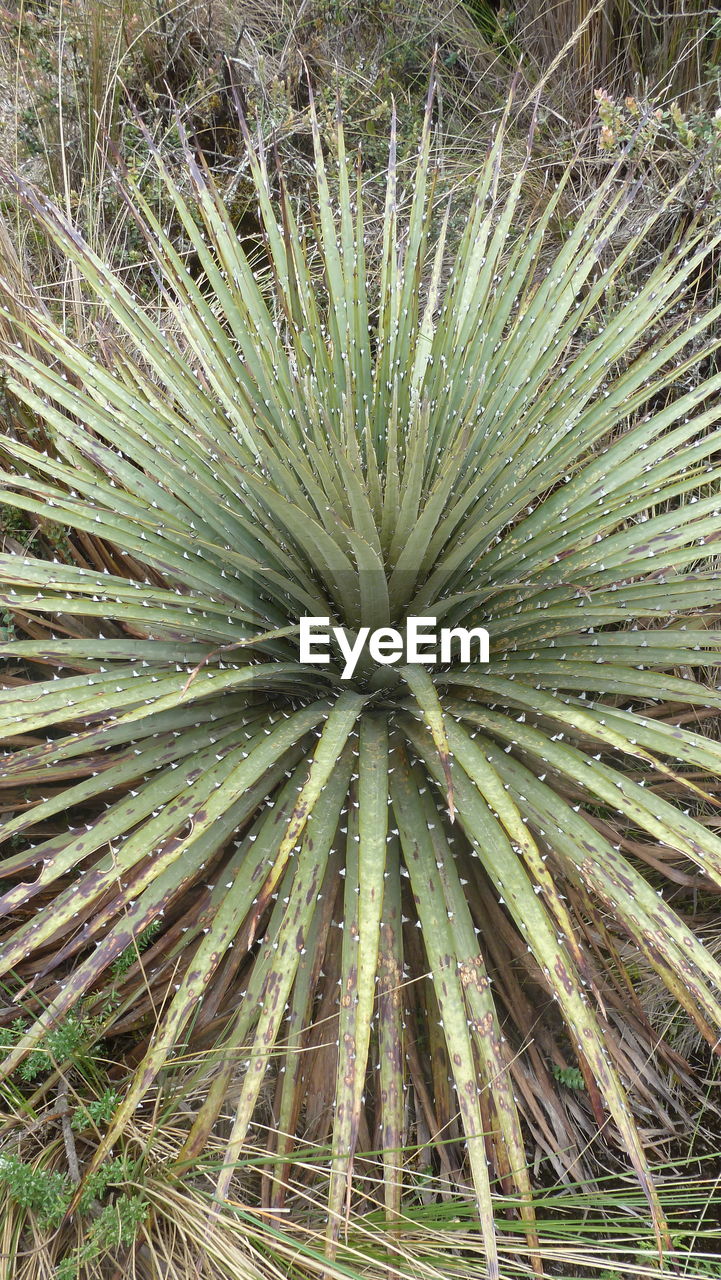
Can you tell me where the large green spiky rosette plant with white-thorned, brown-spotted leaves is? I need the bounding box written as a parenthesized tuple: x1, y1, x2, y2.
(1, 97, 721, 1275)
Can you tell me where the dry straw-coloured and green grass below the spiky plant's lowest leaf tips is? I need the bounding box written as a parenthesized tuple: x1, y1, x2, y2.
(0, 1059, 720, 1280)
